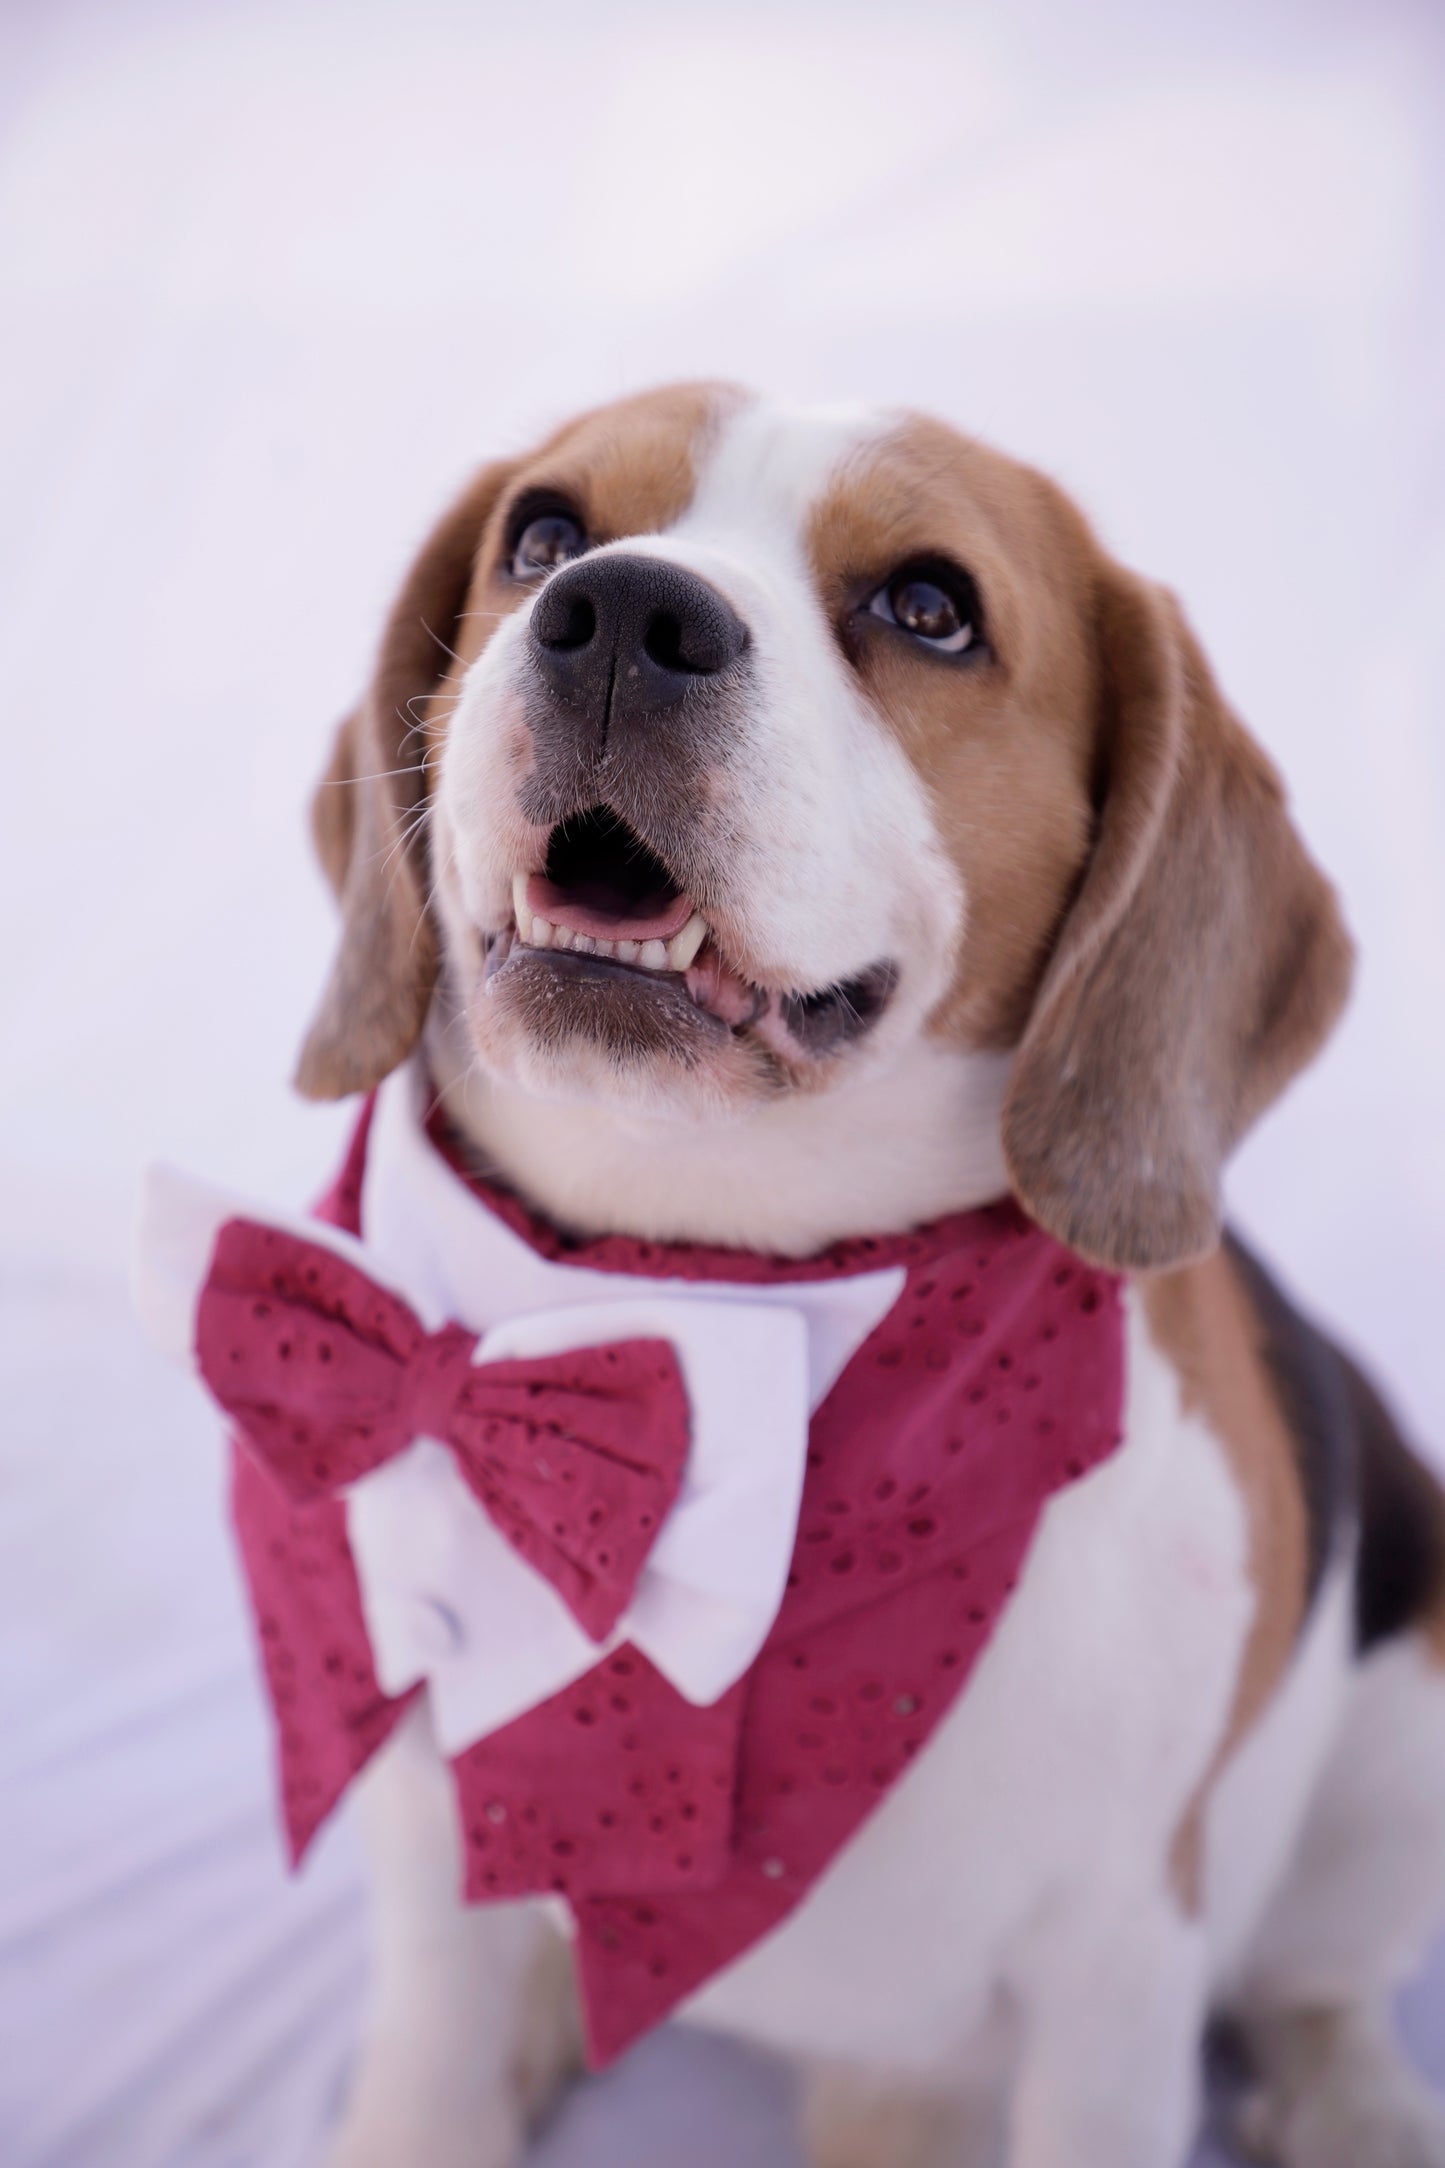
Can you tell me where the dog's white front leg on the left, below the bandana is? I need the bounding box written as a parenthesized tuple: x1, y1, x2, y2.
(327, 1706, 576, 2168)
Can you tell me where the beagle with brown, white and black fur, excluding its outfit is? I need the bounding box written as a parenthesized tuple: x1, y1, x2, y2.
(299, 384, 1445, 2168)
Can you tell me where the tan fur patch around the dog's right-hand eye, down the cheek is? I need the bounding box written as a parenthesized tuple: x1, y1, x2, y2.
(808, 418, 1096, 1047)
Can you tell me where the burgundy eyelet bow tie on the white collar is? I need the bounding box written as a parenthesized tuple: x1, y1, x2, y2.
(195, 1218, 689, 1641)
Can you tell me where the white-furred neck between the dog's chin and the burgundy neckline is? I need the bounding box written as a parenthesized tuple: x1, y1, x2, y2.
(427, 1019, 1010, 1257)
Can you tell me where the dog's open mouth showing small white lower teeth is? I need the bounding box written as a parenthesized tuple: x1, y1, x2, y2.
(487, 806, 897, 1058)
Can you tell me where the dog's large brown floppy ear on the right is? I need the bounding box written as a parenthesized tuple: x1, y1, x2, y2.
(1003, 566, 1352, 1270)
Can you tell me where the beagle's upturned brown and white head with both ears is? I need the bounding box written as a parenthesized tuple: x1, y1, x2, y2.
(299, 386, 1350, 1266)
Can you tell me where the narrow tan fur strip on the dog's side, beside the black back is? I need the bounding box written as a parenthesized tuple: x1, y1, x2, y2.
(1140, 1251, 1309, 1910)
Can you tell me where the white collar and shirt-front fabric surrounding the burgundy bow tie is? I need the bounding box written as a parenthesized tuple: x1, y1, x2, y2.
(136, 1067, 906, 1754)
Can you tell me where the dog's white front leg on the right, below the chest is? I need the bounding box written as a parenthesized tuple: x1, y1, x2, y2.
(1007, 1882, 1207, 2168)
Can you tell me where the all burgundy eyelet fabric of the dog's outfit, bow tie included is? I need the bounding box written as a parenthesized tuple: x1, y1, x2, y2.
(220, 1106, 1124, 2066)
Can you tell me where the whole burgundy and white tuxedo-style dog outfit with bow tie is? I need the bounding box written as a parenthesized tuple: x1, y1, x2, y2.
(141, 1069, 1124, 2064)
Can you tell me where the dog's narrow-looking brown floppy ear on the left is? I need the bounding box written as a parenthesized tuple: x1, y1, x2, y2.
(297, 462, 513, 1099)
